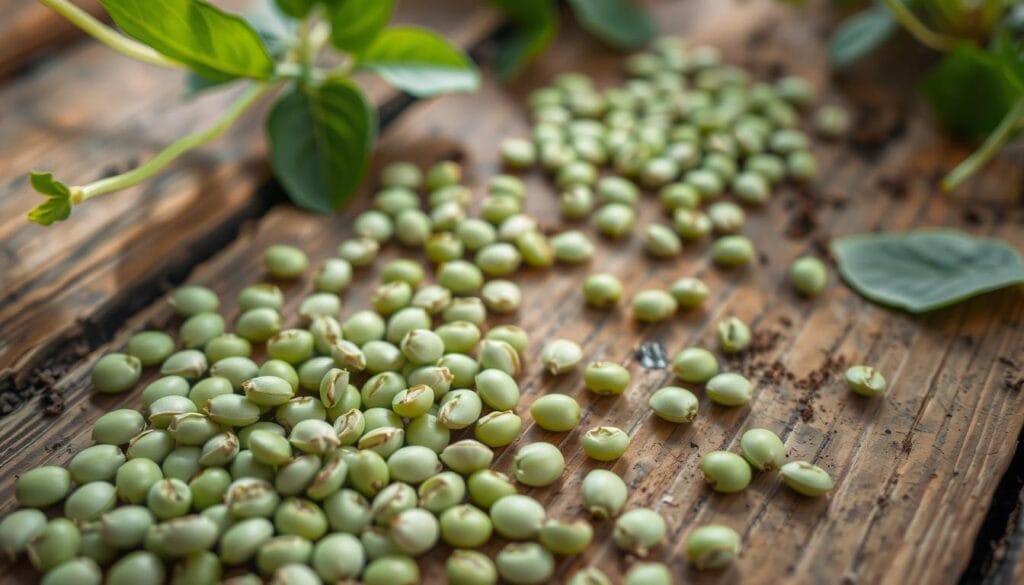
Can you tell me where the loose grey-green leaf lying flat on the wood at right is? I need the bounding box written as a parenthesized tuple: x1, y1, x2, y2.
(833, 229, 1024, 312)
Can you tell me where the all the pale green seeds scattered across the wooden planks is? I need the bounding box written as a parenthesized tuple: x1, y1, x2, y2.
(0, 39, 885, 585)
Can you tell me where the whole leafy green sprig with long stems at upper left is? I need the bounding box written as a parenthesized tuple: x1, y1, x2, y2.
(29, 0, 479, 225)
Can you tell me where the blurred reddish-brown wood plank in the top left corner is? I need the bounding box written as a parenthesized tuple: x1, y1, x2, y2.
(0, 0, 103, 79)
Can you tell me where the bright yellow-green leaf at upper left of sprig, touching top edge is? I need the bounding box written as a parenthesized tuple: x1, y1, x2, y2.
(100, 0, 273, 80)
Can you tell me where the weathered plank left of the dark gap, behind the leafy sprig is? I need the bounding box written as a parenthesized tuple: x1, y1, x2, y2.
(0, 0, 499, 395)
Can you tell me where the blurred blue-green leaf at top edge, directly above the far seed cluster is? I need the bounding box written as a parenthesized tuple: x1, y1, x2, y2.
(569, 0, 657, 49)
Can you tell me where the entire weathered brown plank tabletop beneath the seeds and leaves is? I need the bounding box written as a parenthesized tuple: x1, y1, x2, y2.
(0, 0, 1024, 584)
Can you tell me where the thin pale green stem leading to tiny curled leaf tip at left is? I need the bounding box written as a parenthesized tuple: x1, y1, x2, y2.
(72, 84, 276, 204)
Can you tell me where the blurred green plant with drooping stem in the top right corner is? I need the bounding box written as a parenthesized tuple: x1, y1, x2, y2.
(829, 0, 1024, 190)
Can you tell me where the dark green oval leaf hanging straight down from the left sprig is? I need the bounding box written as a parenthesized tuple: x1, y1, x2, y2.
(266, 80, 377, 213)
